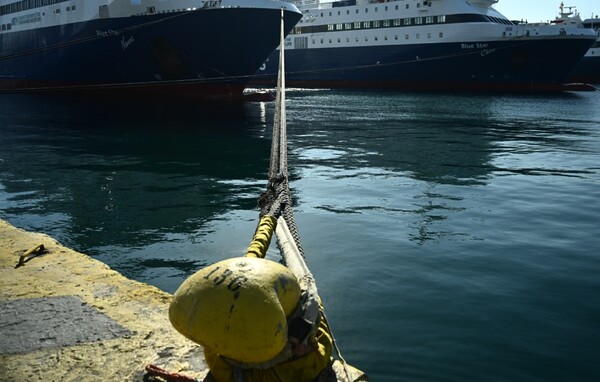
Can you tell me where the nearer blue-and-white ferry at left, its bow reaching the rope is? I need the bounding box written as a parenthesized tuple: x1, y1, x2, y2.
(0, 0, 302, 98)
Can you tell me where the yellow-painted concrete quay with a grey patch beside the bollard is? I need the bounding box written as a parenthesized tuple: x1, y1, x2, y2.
(0, 220, 208, 382)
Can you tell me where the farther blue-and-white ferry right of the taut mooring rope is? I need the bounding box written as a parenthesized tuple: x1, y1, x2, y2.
(257, 0, 597, 91)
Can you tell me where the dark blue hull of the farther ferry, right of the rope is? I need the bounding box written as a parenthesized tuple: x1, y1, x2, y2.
(258, 37, 593, 91)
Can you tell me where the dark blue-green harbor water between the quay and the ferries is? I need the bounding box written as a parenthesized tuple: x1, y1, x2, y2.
(0, 90, 600, 382)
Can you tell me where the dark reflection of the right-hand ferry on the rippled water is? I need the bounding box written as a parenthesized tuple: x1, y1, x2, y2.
(288, 92, 598, 185)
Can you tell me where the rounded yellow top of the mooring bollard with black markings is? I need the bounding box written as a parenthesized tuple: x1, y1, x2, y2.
(169, 257, 300, 363)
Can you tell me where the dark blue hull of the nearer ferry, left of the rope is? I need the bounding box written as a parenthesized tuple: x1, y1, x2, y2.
(0, 8, 301, 98)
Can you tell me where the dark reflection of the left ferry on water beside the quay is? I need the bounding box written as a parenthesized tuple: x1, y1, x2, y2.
(0, 96, 270, 286)
